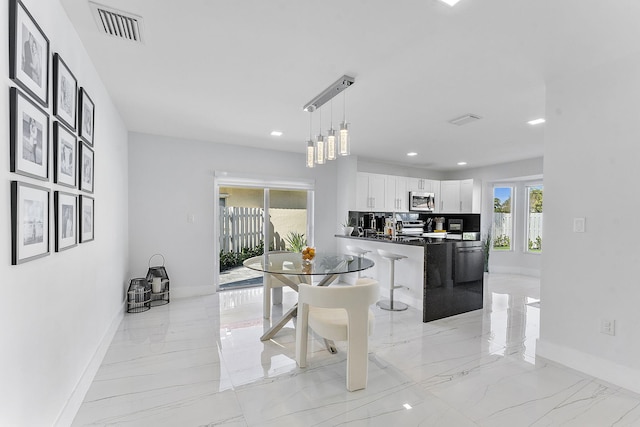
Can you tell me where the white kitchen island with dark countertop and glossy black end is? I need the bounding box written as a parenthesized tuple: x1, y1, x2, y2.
(336, 235, 484, 322)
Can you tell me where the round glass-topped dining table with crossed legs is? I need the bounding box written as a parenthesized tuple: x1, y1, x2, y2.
(243, 251, 374, 342)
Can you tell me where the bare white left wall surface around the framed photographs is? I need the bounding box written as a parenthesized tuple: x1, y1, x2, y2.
(0, 0, 128, 426)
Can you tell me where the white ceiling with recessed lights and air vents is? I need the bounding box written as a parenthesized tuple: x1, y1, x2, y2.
(60, 0, 640, 171)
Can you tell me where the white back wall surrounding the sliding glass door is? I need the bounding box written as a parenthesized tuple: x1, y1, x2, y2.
(129, 133, 339, 296)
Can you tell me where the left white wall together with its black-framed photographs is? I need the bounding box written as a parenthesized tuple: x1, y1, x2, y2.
(0, 0, 134, 426)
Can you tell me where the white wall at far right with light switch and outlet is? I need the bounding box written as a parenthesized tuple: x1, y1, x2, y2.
(537, 51, 640, 392)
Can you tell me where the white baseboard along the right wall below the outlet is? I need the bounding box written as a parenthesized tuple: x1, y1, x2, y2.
(536, 339, 640, 393)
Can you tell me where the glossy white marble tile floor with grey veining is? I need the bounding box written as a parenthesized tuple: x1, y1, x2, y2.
(73, 274, 640, 427)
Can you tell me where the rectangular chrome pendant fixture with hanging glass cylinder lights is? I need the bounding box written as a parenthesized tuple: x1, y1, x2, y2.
(303, 75, 355, 168)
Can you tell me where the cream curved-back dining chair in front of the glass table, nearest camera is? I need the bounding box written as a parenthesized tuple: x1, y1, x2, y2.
(296, 278, 380, 391)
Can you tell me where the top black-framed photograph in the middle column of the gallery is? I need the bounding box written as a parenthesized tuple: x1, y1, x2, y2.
(53, 53, 78, 130)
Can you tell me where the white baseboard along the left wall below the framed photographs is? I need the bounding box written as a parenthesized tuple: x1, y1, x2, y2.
(54, 304, 125, 426)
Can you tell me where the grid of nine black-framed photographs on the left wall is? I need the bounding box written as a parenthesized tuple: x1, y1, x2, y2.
(9, 0, 96, 265)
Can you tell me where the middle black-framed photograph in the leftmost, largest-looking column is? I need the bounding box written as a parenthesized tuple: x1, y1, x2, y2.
(10, 87, 49, 181)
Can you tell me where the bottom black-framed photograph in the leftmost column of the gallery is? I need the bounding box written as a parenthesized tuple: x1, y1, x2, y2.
(11, 181, 49, 265)
